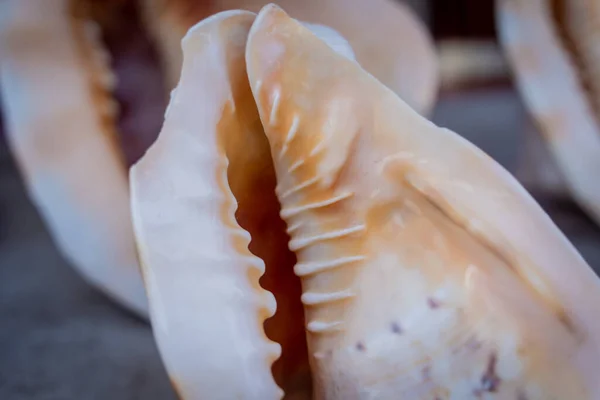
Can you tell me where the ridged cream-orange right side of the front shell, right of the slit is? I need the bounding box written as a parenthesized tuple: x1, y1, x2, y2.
(246, 8, 600, 399)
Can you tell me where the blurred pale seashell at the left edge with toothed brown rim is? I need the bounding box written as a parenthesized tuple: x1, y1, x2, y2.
(0, 0, 147, 316)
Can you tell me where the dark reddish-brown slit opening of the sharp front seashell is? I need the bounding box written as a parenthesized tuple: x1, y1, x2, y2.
(218, 51, 312, 399)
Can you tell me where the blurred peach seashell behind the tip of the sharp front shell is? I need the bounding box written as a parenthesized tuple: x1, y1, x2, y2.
(141, 0, 440, 114)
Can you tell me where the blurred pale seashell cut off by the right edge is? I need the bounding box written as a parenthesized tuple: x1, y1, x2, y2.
(497, 0, 600, 222)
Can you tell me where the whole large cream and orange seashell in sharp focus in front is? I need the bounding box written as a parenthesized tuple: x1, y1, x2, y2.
(130, 5, 600, 400)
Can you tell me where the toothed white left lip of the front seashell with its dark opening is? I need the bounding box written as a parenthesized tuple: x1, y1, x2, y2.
(131, 11, 312, 399)
